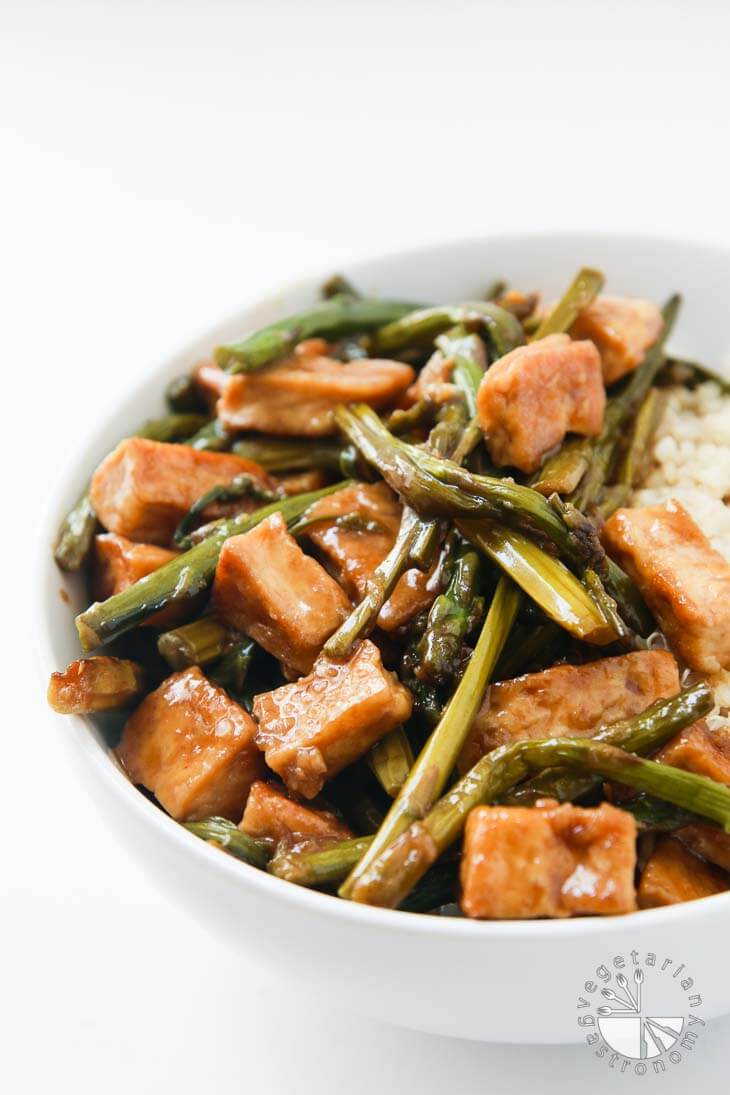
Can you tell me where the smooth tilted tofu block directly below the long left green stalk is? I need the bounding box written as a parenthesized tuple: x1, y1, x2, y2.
(211, 514, 350, 677)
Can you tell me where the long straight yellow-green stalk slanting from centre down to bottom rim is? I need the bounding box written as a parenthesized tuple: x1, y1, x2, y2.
(339, 577, 520, 900)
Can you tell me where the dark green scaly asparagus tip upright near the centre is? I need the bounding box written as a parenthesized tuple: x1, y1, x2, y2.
(418, 544, 480, 684)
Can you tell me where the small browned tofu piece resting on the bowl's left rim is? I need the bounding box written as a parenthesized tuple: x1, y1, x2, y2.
(48, 655, 144, 715)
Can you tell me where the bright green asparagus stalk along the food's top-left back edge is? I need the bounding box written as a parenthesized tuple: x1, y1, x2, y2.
(216, 292, 418, 373)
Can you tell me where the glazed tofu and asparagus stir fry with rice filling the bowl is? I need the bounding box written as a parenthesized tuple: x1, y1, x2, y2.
(48, 268, 730, 920)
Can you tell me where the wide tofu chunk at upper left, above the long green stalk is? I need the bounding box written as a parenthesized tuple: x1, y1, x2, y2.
(91, 437, 269, 544)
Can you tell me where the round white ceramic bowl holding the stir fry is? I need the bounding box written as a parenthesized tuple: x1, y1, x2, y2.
(38, 233, 730, 1042)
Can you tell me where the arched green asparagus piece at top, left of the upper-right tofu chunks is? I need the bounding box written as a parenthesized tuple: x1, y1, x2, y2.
(372, 300, 524, 357)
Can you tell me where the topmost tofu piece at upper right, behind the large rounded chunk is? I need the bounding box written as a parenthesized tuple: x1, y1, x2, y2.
(570, 297, 663, 384)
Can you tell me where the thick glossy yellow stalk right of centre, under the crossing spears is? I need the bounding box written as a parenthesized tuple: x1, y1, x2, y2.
(456, 520, 618, 646)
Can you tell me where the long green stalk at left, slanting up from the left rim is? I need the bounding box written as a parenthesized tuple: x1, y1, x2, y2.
(76, 481, 349, 650)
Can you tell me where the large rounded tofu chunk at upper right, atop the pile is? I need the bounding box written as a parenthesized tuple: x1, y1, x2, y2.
(476, 335, 606, 473)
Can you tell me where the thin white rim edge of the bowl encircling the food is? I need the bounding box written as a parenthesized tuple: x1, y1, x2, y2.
(33, 228, 730, 943)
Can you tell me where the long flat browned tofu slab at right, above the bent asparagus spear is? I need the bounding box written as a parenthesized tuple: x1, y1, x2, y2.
(459, 650, 680, 772)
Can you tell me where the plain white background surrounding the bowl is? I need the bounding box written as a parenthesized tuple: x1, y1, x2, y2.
(0, 0, 730, 1095)
